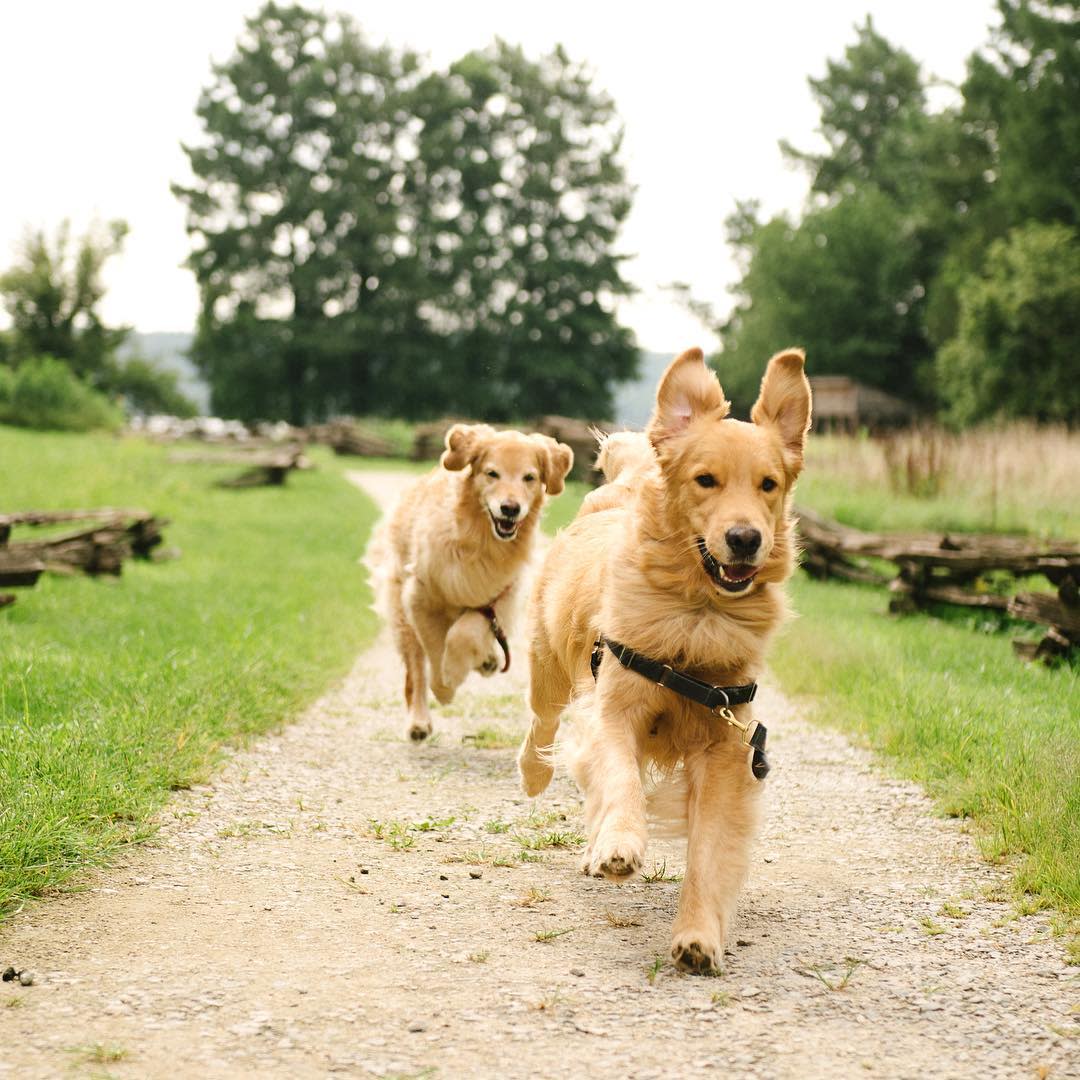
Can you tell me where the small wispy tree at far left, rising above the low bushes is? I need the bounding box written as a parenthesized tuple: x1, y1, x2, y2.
(0, 221, 131, 379)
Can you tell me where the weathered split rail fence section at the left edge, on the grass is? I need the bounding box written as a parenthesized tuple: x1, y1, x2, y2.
(0, 509, 167, 607)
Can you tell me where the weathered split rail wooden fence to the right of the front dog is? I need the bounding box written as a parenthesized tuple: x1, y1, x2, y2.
(796, 509, 1080, 660)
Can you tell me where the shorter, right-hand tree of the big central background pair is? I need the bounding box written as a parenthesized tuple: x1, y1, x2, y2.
(414, 41, 636, 419)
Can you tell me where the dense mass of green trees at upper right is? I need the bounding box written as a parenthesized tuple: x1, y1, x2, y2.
(699, 0, 1080, 424)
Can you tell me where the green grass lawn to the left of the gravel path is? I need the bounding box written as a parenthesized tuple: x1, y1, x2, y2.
(0, 427, 375, 914)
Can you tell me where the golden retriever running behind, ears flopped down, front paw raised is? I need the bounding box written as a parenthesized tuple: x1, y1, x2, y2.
(366, 423, 573, 740)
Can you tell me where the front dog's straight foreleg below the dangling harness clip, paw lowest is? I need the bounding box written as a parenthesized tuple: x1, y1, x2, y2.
(672, 740, 760, 974)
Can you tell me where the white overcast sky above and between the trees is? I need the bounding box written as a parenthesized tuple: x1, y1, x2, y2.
(0, 0, 996, 351)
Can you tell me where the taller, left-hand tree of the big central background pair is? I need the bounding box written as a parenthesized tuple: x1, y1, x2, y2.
(174, 3, 416, 421)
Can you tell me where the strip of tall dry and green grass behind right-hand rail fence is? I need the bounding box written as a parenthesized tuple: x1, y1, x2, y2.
(797, 423, 1080, 538)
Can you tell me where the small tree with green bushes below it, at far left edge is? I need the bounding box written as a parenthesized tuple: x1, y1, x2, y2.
(0, 221, 194, 429)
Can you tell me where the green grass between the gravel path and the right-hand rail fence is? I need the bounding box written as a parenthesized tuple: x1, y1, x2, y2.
(771, 575, 1080, 916)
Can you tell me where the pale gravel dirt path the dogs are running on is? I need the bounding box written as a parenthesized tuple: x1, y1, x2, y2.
(0, 474, 1080, 1080)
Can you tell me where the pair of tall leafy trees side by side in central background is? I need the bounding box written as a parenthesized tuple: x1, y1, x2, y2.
(174, 3, 637, 422)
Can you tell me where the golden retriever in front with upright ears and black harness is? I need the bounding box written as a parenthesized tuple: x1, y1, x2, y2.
(518, 349, 810, 972)
